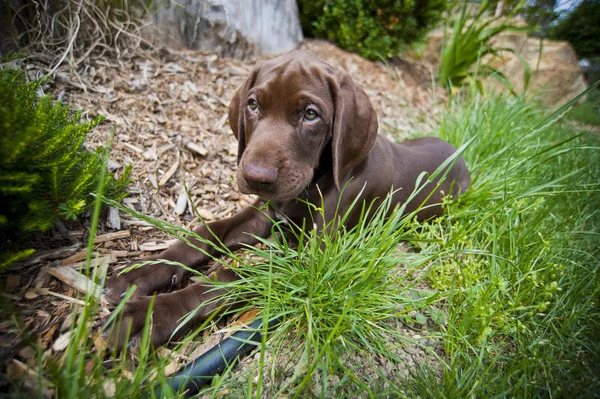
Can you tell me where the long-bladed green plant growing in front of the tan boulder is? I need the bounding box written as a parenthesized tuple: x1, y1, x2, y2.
(438, 1, 531, 91)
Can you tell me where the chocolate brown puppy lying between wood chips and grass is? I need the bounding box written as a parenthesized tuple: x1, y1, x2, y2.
(106, 51, 470, 345)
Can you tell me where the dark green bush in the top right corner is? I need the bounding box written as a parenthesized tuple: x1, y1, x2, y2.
(550, 0, 600, 57)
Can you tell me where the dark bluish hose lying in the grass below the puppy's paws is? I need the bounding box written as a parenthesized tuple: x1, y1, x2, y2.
(154, 318, 280, 398)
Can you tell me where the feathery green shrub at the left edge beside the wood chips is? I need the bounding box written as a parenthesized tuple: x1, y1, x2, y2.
(0, 69, 130, 247)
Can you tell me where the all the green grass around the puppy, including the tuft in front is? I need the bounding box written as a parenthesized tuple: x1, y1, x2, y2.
(9, 88, 600, 398)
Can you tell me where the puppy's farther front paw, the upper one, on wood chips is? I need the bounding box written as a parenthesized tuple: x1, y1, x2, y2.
(103, 263, 186, 305)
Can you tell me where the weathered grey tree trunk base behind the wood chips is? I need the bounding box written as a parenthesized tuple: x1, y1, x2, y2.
(152, 0, 302, 58)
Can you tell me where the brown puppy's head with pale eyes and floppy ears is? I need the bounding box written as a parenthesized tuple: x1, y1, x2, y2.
(229, 51, 377, 201)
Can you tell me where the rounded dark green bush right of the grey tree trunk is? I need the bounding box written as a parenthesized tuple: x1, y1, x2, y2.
(298, 0, 447, 59)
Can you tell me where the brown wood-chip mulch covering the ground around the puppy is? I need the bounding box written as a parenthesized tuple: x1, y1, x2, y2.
(0, 41, 445, 392)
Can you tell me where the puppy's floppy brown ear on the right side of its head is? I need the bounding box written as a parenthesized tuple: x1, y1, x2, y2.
(329, 71, 377, 191)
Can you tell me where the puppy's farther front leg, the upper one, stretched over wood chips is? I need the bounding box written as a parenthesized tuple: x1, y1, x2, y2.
(105, 202, 271, 304)
